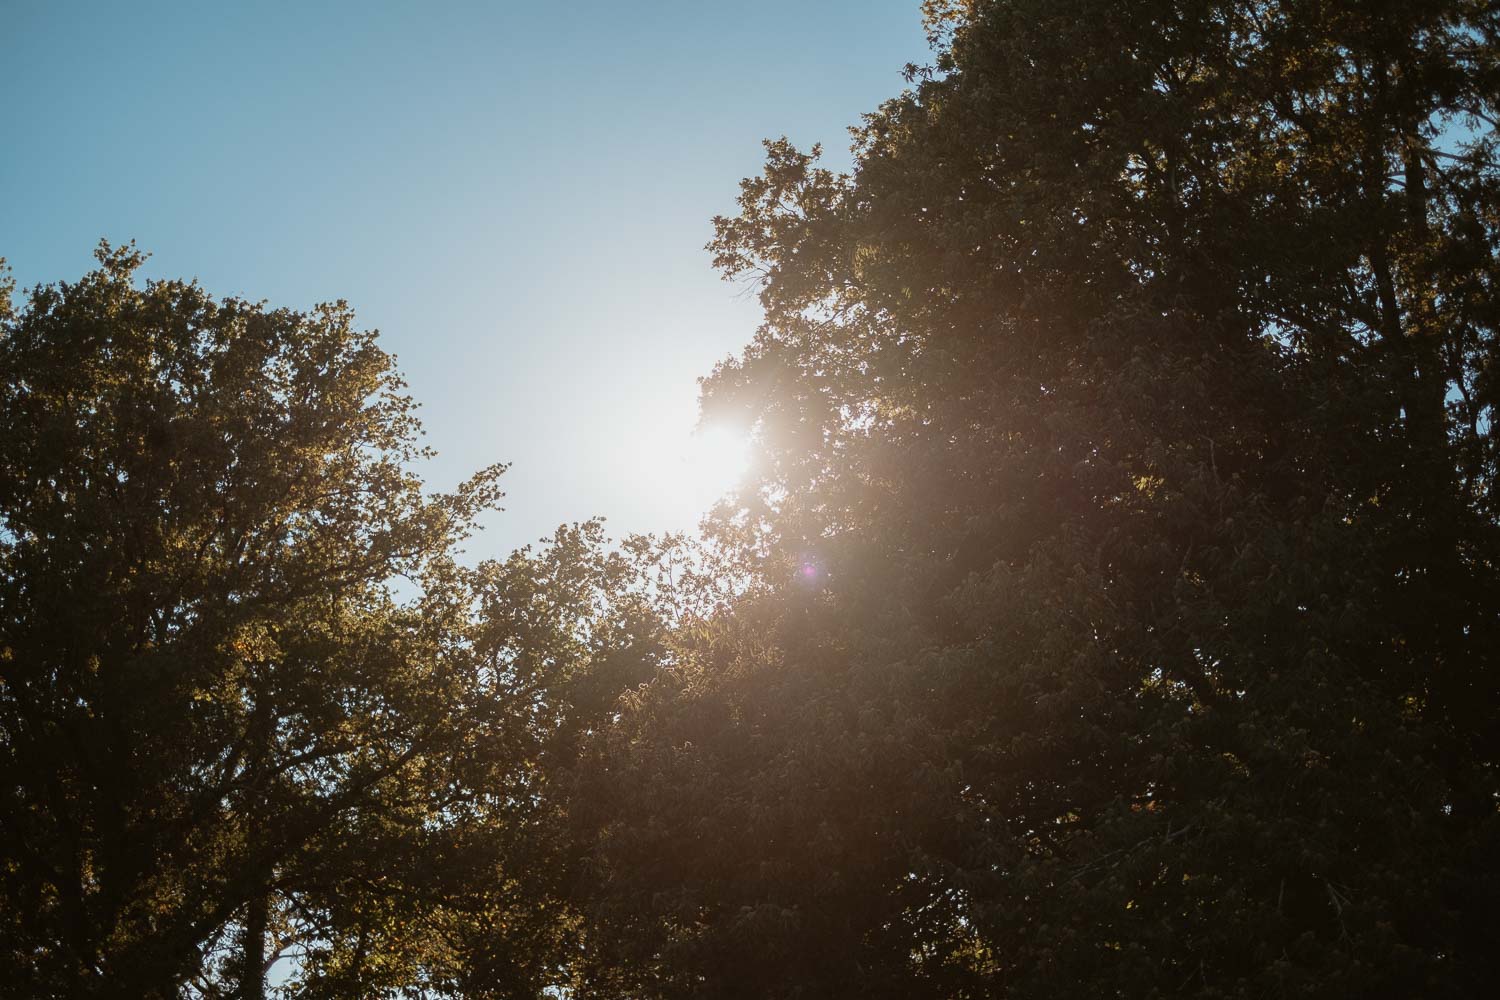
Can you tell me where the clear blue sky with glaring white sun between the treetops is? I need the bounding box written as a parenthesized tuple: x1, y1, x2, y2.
(0, 0, 929, 559)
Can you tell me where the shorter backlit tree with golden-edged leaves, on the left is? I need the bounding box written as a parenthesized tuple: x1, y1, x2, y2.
(0, 244, 639, 997)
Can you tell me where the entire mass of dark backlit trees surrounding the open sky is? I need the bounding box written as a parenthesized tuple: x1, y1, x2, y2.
(0, 0, 1500, 1000)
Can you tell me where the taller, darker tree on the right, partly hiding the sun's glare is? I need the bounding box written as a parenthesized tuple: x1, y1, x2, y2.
(570, 0, 1500, 997)
